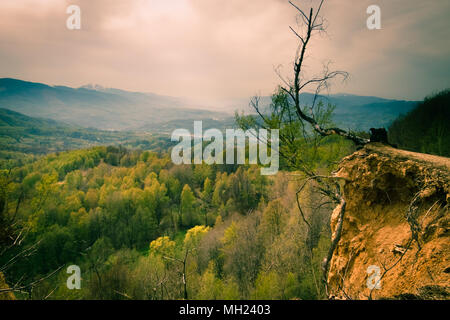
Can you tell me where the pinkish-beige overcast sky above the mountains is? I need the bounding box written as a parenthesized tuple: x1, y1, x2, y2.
(0, 0, 450, 100)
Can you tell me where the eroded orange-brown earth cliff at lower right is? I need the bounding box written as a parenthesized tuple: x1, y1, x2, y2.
(328, 144, 450, 299)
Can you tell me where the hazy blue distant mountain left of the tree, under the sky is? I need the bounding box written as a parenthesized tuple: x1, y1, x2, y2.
(0, 78, 229, 130)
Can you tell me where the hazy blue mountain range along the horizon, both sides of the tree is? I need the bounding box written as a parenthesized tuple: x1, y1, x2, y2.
(0, 78, 417, 133)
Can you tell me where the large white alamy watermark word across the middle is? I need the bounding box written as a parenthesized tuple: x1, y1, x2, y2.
(171, 121, 280, 175)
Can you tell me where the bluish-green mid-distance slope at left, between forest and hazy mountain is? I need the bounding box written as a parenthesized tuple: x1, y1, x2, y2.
(0, 108, 172, 162)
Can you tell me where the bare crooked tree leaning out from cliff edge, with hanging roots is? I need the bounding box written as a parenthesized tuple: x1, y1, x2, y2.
(241, 0, 370, 295)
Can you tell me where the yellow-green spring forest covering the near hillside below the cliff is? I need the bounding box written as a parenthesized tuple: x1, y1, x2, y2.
(0, 145, 335, 299)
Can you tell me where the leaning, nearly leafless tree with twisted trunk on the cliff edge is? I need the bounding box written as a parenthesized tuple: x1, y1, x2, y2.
(237, 0, 370, 295)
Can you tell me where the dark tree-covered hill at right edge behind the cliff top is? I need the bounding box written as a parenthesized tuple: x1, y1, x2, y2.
(389, 89, 450, 157)
